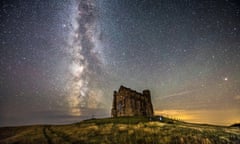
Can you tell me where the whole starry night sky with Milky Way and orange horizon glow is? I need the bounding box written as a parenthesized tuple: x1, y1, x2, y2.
(0, 0, 240, 126)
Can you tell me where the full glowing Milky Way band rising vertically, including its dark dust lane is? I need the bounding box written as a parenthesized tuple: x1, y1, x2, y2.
(66, 0, 109, 116)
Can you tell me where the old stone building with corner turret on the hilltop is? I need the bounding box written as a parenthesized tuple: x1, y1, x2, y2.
(111, 86, 153, 117)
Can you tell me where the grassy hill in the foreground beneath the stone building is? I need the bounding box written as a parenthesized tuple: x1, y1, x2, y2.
(0, 117, 240, 144)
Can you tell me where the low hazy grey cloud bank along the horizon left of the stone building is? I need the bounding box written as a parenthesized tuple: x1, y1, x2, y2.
(0, 108, 110, 126)
